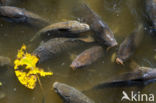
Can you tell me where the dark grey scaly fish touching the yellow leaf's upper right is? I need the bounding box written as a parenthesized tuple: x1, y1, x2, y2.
(33, 38, 92, 64)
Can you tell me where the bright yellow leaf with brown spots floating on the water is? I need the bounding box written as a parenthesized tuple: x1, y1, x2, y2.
(14, 45, 53, 89)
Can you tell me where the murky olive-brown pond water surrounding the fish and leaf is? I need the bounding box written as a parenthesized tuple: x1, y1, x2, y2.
(0, 0, 156, 103)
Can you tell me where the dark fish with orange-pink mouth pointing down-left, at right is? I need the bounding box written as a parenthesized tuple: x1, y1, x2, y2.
(116, 24, 144, 65)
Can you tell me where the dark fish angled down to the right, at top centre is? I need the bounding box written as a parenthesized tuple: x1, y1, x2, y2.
(78, 4, 118, 48)
